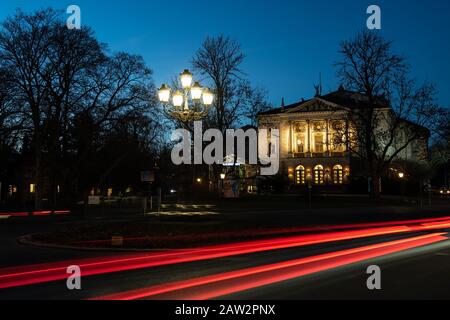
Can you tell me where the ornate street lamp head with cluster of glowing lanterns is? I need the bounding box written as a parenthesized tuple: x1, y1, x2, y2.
(158, 70, 214, 122)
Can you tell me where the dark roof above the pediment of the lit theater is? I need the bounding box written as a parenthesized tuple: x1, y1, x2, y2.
(259, 87, 390, 115)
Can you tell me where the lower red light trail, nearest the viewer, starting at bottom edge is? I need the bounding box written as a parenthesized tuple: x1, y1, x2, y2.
(90, 233, 448, 300)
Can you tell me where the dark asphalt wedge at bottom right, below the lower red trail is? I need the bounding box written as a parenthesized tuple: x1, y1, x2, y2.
(225, 238, 450, 300)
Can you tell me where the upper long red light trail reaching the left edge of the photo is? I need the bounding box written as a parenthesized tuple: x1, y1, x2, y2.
(0, 218, 450, 289)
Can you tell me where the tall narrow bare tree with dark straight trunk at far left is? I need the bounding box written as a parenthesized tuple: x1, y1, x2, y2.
(38, 21, 107, 203)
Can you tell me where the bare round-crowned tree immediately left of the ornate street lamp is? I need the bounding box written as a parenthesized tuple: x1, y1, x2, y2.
(58, 52, 163, 202)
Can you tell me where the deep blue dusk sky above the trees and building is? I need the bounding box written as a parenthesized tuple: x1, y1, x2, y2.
(0, 0, 450, 106)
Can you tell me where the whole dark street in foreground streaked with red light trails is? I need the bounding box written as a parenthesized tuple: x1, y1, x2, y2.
(0, 212, 450, 300)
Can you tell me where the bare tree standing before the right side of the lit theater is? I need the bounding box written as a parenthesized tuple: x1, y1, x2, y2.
(336, 31, 440, 197)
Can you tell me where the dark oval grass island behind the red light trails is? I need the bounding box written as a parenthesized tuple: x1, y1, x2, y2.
(33, 221, 296, 249)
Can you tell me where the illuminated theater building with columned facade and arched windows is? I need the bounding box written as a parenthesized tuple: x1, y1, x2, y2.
(258, 87, 428, 192)
